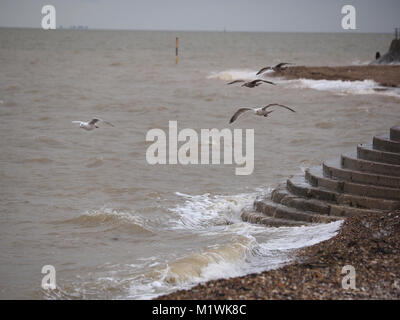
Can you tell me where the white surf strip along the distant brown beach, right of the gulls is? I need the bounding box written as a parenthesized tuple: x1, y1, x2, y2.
(288, 79, 400, 97)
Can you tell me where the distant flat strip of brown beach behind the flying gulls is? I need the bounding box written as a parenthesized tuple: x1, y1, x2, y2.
(268, 65, 400, 87)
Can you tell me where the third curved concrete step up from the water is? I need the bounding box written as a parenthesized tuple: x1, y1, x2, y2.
(271, 188, 382, 217)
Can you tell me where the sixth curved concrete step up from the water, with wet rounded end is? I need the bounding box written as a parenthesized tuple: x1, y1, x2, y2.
(322, 159, 400, 188)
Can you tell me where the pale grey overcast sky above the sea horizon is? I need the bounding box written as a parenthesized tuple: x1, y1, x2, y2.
(0, 0, 400, 33)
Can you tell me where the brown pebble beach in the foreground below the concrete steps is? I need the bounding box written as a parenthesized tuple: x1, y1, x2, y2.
(158, 210, 400, 300)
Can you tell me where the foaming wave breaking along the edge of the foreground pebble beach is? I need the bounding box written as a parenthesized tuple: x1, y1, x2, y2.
(124, 221, 342, 299)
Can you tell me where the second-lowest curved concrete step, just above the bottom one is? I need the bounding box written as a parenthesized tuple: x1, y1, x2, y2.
(254, 197, 340, 223)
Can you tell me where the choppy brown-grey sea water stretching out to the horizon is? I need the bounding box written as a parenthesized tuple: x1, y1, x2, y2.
(0, 29, 399, 299)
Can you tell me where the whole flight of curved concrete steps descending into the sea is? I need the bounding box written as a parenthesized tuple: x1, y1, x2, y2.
(241, 126, 400, 227)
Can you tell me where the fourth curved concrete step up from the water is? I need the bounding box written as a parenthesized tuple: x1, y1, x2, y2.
(286, 176, 400, 210)
